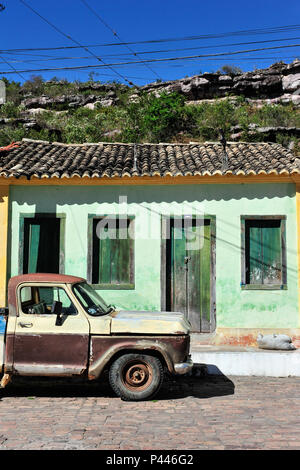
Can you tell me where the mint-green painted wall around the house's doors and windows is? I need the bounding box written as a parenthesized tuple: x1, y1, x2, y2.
(9, 183, 299, 328)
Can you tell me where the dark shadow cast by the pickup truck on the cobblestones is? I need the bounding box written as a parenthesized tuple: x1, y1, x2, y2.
(0, 364, 234, 400)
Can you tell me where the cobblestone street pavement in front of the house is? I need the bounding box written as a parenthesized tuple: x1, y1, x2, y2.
(0, 369, 300, 450)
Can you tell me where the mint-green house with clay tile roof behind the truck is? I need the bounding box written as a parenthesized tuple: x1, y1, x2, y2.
(0, 141, 300, 345)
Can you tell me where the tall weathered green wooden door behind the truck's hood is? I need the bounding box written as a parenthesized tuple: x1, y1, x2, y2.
(166, 219, 211, 333)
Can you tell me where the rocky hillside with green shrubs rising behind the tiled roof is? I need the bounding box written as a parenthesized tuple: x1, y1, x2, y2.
(0, 60, 300, 153)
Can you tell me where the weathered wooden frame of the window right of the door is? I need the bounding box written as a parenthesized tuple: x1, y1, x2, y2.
(241, 215, 287, 290)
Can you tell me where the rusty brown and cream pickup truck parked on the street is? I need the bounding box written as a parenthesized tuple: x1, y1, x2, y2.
(0, 274, 193, 400)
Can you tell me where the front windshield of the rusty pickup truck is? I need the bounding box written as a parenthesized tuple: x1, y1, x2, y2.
(73, 282, 114, 316)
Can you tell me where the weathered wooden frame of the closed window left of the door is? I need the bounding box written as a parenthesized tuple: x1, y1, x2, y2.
(87, 214, 135, 290)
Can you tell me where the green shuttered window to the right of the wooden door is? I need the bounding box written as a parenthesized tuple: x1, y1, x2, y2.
(242, 216, 286, 289)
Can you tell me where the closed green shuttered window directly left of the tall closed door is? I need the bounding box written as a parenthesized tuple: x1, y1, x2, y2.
(90, 216, 134, 289)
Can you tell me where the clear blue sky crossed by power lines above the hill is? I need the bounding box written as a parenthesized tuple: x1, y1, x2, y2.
(0, 0, 300, 85)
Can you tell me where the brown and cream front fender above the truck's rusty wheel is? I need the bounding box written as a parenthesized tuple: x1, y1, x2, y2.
(88, 336, 187, 380)
